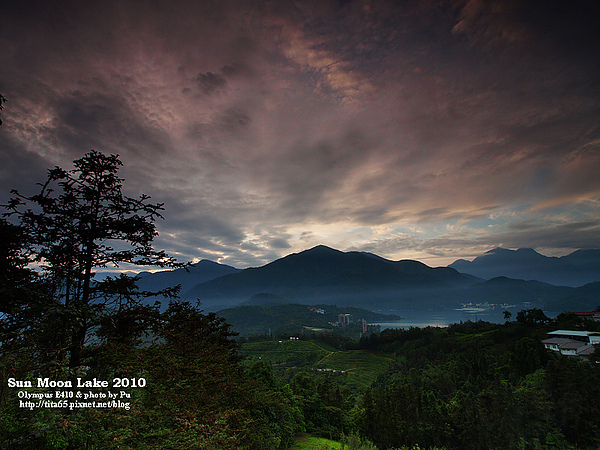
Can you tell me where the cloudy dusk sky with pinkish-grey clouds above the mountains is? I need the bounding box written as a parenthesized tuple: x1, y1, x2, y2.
(0, 0, 600, 268)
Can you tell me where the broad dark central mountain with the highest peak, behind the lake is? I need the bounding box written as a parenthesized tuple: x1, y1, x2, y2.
(185, 245, 479, 308)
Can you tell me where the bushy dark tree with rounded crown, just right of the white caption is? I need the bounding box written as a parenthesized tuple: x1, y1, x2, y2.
(102, 301, 299, 450)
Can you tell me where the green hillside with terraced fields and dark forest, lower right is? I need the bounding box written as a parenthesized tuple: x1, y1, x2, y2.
(236, 310, 600, 449)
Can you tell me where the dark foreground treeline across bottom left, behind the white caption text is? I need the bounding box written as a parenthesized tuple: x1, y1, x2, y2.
(0, 303, 308, 449)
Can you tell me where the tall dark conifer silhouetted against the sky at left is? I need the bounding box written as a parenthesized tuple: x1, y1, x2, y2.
(5, 150, 178, 369)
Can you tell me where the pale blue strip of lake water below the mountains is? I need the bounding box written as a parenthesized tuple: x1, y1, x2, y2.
(370, 307, 556, 330)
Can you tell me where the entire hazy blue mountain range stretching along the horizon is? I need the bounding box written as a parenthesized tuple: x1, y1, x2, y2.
(134, 245, 600, 311)
